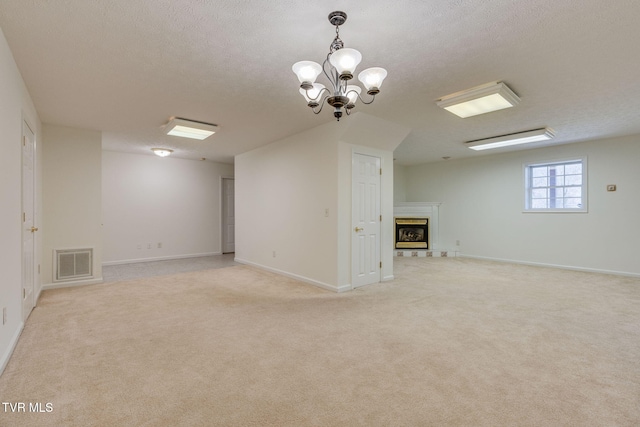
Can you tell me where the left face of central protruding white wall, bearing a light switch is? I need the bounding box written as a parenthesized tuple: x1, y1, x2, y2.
(235, 123, 339, 289)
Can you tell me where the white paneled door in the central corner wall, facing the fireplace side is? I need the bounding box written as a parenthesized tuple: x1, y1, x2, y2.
(351, 153, 381, 288)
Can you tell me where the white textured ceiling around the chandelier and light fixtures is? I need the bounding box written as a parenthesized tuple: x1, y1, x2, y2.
(0, 0, 640, 164)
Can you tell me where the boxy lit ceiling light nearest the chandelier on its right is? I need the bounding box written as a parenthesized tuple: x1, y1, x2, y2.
(436, 82, 520, 118)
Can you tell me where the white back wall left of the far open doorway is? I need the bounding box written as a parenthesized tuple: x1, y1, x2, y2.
(102, 151, 234, 264)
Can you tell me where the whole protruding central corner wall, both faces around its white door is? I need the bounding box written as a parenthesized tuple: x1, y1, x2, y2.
(235, 113, 409, 291)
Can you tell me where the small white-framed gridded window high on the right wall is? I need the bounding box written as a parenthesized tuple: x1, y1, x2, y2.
(524, 159, 587, 212)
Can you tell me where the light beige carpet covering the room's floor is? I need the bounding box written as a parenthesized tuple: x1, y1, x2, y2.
(0, 258, 640, 426)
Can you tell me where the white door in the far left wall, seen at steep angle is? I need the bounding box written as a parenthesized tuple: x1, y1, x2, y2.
(22, 122, 38, 320)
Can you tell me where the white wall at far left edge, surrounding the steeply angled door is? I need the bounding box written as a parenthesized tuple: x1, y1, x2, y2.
(0, 26, 42, 373)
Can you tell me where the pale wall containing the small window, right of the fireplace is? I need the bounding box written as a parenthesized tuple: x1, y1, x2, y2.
(405, 135, 640, 275)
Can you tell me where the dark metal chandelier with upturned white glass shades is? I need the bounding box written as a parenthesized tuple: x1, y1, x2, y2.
(291, 11, 387, 121)
